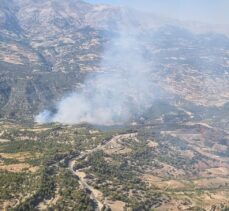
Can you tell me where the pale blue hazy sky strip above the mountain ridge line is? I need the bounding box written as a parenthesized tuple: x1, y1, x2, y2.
(86, 0, 229, 25)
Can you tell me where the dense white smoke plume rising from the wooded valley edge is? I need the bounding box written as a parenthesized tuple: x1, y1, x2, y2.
(36, 10, 155, 125)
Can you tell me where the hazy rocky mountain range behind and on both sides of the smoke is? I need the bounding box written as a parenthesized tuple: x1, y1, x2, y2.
(0, 0, 229, 123)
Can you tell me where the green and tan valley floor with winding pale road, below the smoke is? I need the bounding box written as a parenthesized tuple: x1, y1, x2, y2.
(0, 121, 229, 211)
